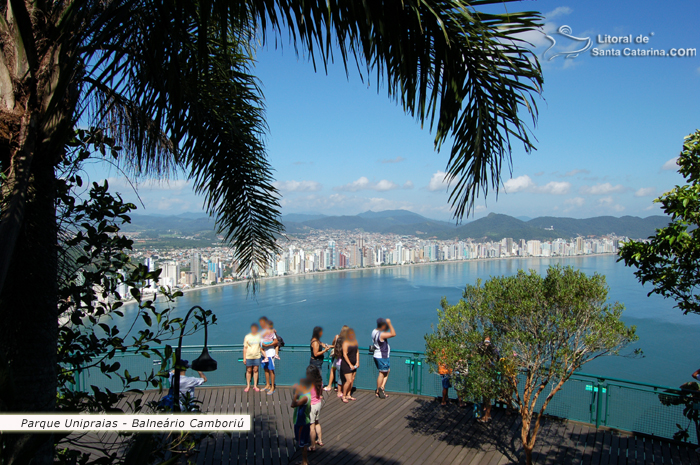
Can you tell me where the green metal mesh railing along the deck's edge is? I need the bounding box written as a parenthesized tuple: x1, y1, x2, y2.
(76, 344, 700, 443)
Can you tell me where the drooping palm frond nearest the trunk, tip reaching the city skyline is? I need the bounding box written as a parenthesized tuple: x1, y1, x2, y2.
(78, 2, 282, 271)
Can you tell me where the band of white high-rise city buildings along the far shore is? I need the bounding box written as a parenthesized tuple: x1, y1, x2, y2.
(129, 226, 627, 288)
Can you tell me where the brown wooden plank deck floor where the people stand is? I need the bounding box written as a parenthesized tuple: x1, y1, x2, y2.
(69, 387, 700, 465)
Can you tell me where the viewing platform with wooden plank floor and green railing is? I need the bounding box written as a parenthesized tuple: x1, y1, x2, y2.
(69, 345, 700, 465)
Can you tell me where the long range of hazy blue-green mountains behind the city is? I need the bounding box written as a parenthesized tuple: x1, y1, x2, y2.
(123, 210, 669, 240)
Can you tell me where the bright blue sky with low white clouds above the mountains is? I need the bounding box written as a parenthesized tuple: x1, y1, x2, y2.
(90, 0, 700, 219)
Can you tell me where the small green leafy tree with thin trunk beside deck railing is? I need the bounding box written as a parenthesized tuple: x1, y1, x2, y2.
(426, 267, 638, 464)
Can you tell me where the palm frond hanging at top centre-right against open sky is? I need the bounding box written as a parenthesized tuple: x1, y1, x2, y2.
(247, 0, 543, 220)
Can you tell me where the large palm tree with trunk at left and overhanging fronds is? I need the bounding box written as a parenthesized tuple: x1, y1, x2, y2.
(0, 0, 542, 460)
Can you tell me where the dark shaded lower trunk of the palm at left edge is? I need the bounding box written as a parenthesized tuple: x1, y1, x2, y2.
(0, 132, 58, 464)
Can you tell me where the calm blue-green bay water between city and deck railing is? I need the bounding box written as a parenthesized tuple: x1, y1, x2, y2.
(127, 255, 700, 386)
